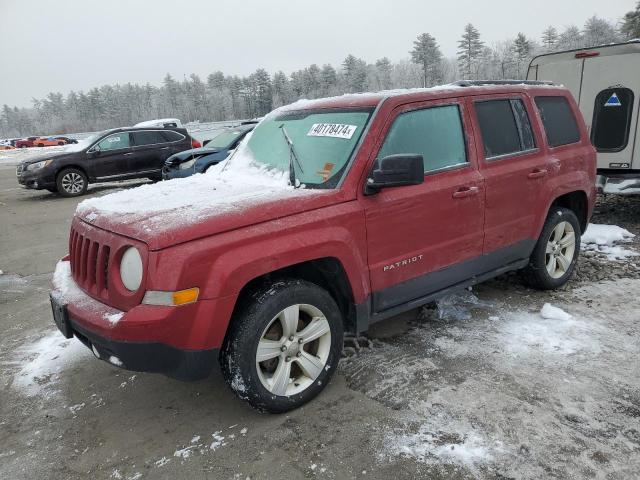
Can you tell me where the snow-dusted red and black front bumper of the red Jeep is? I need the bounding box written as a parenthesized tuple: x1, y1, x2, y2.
(51, 261, 232, 380)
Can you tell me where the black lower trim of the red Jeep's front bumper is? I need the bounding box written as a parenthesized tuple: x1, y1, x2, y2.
(71, 320, 218, 380)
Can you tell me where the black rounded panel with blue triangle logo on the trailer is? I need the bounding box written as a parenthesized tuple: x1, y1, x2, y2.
(591, 88, 633, 152)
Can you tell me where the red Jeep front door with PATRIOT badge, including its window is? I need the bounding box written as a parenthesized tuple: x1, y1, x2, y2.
(363, 99, 484, 312)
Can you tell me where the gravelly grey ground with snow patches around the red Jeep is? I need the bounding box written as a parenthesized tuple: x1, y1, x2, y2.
(0, 165, 640, 480)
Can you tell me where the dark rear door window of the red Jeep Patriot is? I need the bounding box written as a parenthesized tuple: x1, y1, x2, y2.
(475, 99, 536, 159)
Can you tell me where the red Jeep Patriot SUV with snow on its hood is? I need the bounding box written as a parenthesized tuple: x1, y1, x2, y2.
(51, 82, 596, 412)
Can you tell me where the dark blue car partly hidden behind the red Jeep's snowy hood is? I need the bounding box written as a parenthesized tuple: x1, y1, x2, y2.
(162, 123, 256, 180)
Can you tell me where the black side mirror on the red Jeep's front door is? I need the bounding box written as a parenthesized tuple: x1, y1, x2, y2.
(364, 153, 424, 195)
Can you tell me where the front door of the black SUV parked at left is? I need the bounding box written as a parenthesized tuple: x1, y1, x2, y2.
(88, 132, 133, 180)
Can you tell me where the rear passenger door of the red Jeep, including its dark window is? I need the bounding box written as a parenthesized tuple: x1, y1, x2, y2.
(469, 94, 558, 258)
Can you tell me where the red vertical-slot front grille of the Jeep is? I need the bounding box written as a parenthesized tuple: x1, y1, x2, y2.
(69, 229, 111, 301)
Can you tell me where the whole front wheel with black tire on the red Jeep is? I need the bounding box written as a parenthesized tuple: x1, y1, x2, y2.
(220, 279, 343, 413)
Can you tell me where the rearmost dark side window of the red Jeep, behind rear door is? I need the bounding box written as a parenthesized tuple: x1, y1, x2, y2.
(536, 97, 580, 147)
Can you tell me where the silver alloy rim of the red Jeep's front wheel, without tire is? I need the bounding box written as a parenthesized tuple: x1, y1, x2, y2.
(256, 304, 331, 396)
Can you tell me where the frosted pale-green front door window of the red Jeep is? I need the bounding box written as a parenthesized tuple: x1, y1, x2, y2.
(378, 105, 467, 173)
